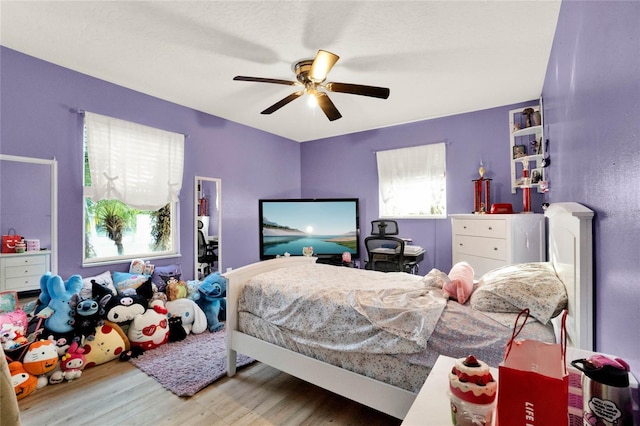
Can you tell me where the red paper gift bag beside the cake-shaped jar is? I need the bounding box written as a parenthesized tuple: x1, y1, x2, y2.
(496, 309, 569, 426)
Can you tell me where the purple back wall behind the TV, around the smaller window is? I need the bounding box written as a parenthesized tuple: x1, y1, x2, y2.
(301, 102, 543, 273)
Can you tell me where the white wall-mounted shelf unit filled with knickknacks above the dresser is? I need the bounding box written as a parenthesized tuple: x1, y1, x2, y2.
(509, 102, 547, 194)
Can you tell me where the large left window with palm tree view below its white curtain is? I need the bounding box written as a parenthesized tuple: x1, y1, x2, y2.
(83, 112, 184, 264)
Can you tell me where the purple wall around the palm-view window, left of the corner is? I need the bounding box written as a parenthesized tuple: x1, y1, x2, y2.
(0, 47, 300, 279)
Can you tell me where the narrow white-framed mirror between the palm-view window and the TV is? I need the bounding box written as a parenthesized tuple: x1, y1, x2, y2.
(193, 176, 222, 280)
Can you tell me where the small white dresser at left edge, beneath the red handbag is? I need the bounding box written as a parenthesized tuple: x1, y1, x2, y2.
(0, 251, 51, 291)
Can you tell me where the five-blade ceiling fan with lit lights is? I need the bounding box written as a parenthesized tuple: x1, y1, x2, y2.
(233, 50, 389, 121)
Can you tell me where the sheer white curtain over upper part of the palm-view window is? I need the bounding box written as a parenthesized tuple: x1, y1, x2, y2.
(84, 112, 184, 210)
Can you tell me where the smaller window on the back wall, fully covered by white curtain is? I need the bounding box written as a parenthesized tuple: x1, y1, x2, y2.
(376, 143, 447, 219)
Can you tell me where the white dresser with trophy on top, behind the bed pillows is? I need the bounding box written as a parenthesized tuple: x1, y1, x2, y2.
(450, 213, 546, 278)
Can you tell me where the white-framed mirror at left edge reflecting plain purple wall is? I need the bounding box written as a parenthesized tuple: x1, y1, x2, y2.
(0, 154, 58, 274)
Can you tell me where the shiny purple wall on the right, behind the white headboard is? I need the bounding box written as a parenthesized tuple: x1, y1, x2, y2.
(543, 1, 640, 377)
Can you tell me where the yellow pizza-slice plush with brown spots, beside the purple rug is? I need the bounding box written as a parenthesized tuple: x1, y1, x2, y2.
(82, 321, 130, 368)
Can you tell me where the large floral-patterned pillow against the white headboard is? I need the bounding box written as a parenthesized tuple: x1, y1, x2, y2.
(471, 262, 568, 324)
